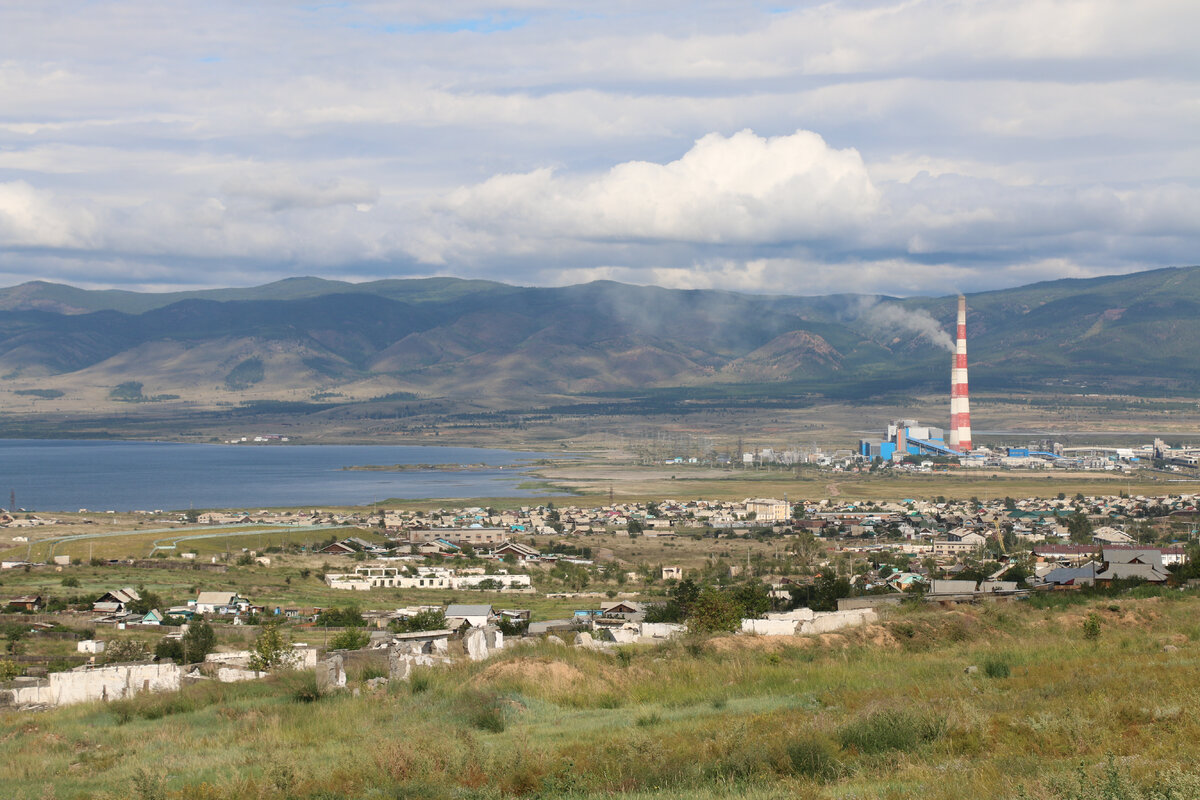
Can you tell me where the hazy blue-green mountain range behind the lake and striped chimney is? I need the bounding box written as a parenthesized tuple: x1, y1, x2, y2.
(0, 267, 1200, 404)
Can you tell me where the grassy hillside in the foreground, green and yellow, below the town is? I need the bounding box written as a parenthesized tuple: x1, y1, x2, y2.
(0, 593, 1200, 800)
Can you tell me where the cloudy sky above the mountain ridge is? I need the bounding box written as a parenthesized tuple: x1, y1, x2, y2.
(0, 0, 1200, 295)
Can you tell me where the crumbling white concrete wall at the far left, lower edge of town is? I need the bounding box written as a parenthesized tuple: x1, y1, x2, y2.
(0, 662, 181, 705)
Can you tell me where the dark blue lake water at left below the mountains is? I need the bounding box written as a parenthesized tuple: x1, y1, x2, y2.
(0, 439, 559, 511)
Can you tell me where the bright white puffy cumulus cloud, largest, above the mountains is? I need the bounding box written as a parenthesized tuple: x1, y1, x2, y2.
(437, 131, 880, 243)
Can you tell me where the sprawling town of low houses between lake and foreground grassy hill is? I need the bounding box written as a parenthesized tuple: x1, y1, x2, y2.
(0, 484, 1200, 706)
